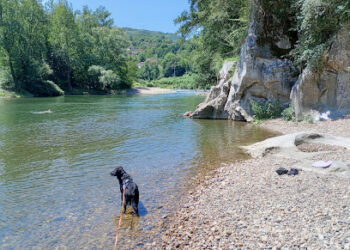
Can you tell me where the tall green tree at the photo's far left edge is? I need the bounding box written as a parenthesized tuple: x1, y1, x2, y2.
(0, 0, 51, 90)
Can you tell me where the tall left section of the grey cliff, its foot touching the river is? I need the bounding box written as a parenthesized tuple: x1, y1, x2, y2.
(191, 1, 296, 121)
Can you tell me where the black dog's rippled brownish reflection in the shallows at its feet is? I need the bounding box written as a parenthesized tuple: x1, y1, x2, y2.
(113, 201, 147, 237)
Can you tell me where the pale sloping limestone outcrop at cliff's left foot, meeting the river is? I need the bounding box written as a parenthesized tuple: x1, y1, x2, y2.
(190, 62, 236, 119)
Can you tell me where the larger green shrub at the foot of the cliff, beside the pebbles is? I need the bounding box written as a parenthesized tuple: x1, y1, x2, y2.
(250, 100, 282, 120)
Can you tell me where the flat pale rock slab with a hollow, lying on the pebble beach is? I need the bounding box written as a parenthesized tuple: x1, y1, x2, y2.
(241, 132, 350, 178)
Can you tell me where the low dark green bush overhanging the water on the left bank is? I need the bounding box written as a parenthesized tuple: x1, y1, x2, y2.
(26, 81, 64, 97)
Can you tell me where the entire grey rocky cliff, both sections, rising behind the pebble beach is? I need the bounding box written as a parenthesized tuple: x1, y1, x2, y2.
(190, 0, 350, 121)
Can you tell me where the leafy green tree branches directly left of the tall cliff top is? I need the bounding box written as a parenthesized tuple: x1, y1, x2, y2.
(175, 0, 249, 86)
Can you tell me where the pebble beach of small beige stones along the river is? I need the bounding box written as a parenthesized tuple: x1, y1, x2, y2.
(162, 118, 350, 249)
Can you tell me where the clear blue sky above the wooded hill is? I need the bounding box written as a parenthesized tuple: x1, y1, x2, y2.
(69, 0, 189, 33)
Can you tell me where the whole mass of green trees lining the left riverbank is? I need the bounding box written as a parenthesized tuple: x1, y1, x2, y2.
(0, 0, 132, 96)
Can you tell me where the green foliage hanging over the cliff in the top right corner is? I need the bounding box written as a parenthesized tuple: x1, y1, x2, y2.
(291, 0, 350, 68)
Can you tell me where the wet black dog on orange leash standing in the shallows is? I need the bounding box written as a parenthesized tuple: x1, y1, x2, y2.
(111, 167, 139, 215)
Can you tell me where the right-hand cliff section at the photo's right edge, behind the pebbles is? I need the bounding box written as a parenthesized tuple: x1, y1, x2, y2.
(291, 23, 350, 120)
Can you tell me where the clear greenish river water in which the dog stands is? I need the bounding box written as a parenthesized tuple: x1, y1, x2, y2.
(0, 92, 272, 249)
